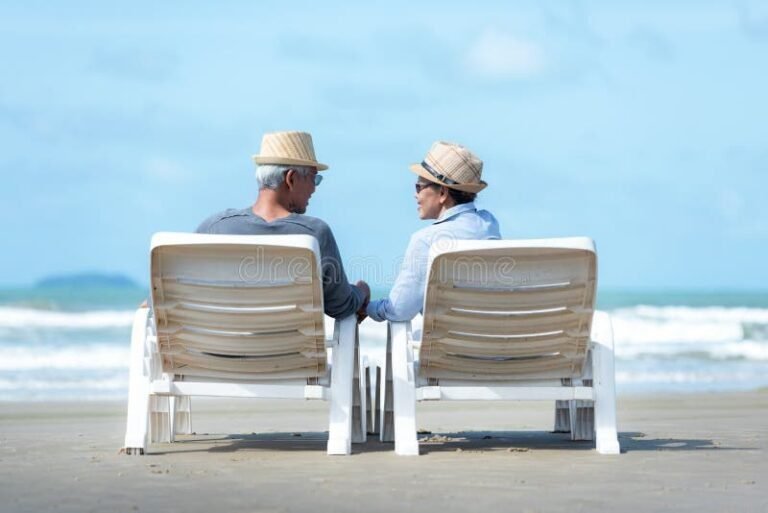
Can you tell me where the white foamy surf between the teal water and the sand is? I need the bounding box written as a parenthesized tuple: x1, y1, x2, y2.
(0, 306, 768, 400)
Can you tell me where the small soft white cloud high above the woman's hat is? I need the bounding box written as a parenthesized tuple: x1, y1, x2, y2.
(465, 30, 545, 79)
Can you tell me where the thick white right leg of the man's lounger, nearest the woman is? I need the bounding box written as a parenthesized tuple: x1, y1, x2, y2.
(328, 315, 357, 454)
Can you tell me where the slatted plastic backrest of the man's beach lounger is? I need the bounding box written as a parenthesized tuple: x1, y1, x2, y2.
(151, 233, 326, 380)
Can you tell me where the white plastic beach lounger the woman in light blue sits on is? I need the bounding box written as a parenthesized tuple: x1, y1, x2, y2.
(379, 237, 619, 455)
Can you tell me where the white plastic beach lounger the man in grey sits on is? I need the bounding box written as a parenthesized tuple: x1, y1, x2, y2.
(125, 233, 366, 454)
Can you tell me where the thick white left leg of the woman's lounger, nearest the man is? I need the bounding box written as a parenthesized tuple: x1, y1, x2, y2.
(389, 322, 419, 456)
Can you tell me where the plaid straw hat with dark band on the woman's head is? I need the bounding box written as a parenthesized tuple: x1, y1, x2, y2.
(411, 141, 488, 192)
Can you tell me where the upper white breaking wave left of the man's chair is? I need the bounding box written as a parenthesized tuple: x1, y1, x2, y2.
(0, 307, 134, 329)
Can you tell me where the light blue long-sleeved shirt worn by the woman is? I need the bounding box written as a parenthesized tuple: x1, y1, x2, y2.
(367, 202, 501, 321)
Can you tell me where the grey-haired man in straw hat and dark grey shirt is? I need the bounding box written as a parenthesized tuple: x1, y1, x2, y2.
(197, 132, 371, 319)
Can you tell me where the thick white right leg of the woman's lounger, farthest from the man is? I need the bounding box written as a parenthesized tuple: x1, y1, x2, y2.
(591, 312, 620, 454)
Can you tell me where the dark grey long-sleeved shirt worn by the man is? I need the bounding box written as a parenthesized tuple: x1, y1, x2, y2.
(197, 207, 365, 319)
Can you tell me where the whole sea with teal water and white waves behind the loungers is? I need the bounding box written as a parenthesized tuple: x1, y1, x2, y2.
(0, 287, 768, 401)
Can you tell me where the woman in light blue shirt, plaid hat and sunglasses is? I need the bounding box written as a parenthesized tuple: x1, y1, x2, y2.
(366, 141, 501, 321)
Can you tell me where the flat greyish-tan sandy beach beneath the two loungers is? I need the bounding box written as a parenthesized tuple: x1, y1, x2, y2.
(0, 391, 768, 513)
